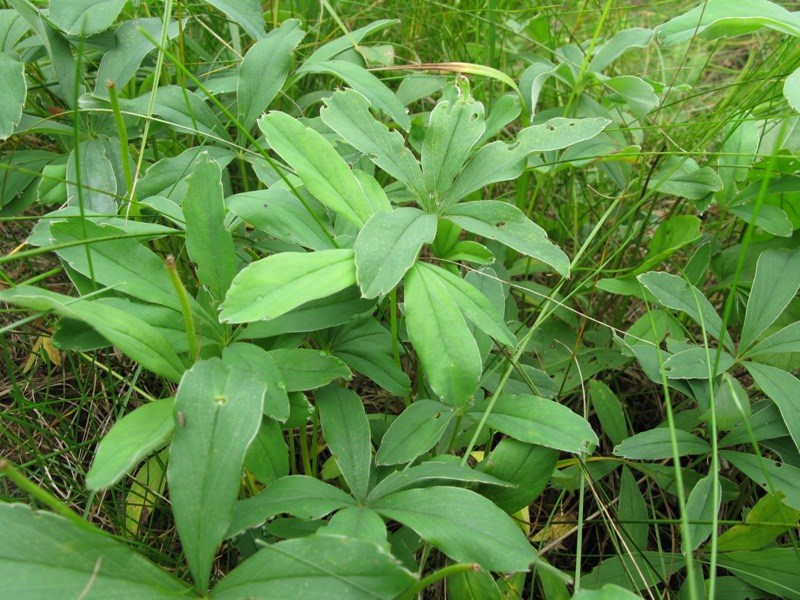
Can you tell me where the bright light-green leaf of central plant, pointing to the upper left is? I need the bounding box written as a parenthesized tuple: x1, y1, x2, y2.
(258, 111, 382, 228)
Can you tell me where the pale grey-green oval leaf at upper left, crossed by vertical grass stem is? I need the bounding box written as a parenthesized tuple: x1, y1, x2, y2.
(67, 139, 117, 215)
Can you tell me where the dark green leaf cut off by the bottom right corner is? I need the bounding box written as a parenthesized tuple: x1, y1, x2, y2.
(717, 548, 800, 600)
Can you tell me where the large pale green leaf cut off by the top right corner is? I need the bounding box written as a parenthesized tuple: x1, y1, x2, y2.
(656, 0, 800, 46)
